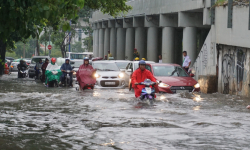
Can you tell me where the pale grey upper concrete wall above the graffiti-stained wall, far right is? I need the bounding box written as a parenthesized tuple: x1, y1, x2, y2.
(215, 6, 250, 48)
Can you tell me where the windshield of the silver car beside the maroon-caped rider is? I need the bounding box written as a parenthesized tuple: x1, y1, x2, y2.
(93, 62, 119, 71)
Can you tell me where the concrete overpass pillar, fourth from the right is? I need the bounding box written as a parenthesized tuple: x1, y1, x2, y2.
(134, 27, 147, 58)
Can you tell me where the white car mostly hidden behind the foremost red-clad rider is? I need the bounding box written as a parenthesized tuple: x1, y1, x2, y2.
(125, 61, 155, 86)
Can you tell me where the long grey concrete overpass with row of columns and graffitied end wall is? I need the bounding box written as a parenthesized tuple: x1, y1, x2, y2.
(91, 0, 250, 96)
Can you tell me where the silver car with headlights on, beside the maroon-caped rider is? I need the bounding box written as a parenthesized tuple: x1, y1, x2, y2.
(93, 61, 125, 88)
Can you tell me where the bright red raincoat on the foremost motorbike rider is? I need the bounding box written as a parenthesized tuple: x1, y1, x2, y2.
(131, 68, 158, 98)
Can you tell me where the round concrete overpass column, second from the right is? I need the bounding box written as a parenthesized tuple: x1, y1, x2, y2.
(162, 27, 175, 63)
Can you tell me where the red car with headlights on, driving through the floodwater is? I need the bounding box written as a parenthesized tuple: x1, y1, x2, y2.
(146, 63, 200, 93)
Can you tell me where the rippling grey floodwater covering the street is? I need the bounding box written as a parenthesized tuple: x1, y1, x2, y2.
(0, 73, 250, 150)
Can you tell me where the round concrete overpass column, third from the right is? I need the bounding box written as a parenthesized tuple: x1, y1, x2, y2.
(147, 27, 158, 62)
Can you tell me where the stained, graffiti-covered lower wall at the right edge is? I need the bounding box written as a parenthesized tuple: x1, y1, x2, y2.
(218, 45, 250, 96)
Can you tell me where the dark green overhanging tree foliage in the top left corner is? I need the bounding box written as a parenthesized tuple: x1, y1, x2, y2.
(0, 0, 84, 75)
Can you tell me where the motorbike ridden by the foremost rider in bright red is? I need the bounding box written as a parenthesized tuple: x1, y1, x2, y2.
(139, 79, 156, 105)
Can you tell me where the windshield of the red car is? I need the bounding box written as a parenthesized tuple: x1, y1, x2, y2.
(153, 66, 189, 77)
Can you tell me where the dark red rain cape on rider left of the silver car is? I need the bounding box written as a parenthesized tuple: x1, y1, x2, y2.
(76, 64, 96, 89)
